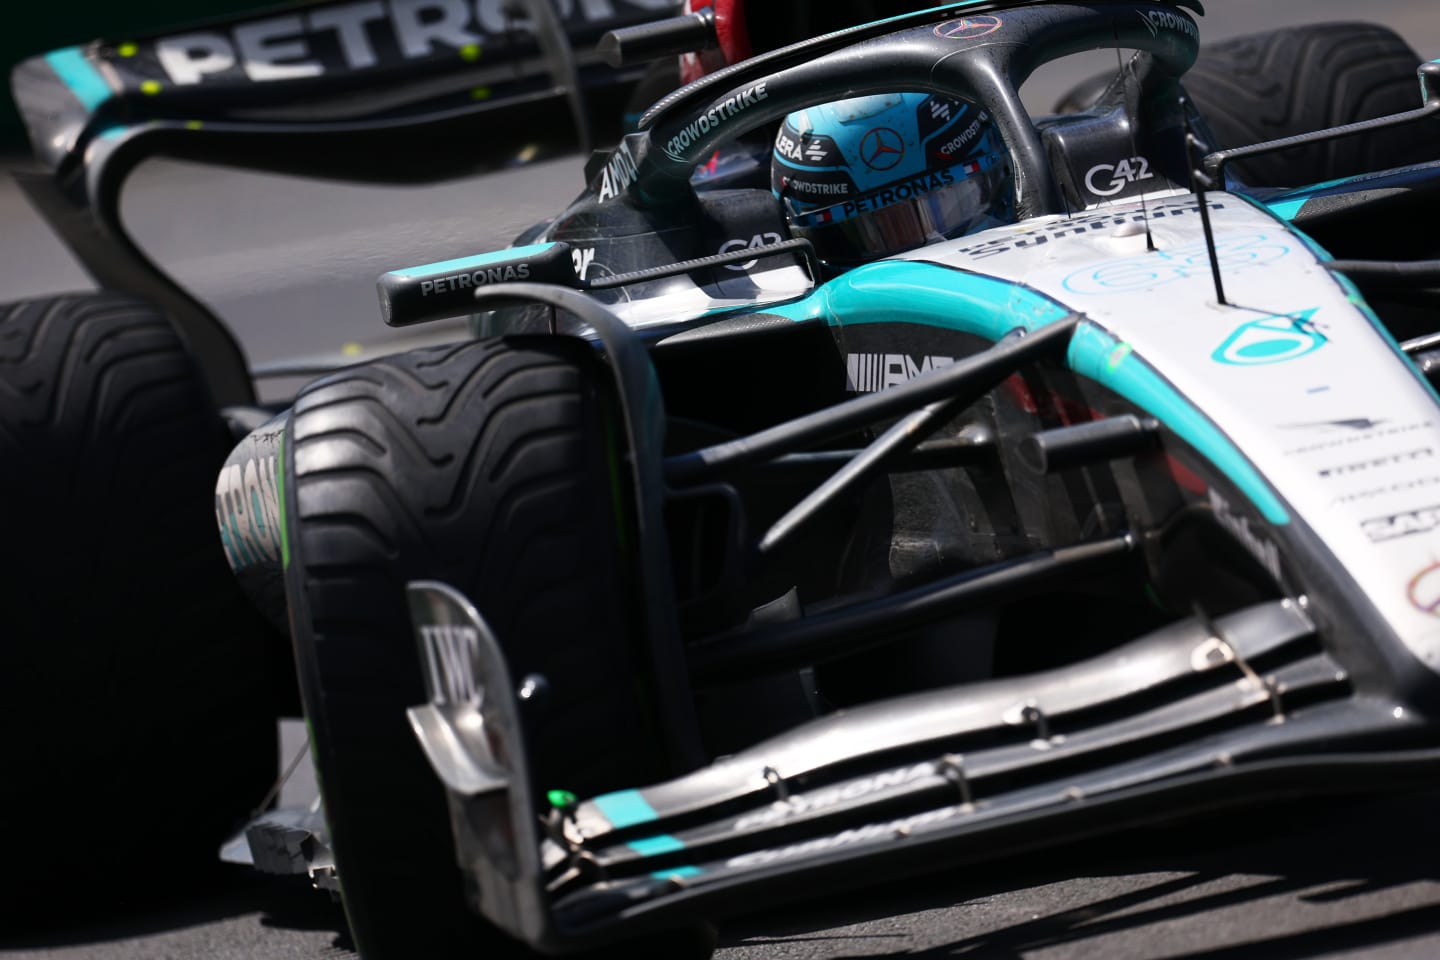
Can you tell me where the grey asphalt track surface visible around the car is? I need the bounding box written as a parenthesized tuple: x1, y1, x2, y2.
(8, 0, 1440, 960)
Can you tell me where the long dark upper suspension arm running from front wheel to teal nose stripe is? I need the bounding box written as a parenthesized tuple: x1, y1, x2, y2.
(665, 317, 1079, 486)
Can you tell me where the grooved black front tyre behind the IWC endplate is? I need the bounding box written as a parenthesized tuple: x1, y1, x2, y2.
(285, 337, 658, 960)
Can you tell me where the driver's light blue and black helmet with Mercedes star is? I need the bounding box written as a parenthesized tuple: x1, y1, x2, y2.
(770, 94, 1014, 266)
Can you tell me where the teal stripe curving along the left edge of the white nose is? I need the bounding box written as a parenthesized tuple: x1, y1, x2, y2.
(765, 261, 1290, 524)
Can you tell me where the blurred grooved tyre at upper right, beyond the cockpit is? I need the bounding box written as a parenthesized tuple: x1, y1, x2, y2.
(1184, 23, 1437, 187)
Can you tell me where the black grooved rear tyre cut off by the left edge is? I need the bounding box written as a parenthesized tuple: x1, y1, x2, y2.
(0, 294, 276, 915)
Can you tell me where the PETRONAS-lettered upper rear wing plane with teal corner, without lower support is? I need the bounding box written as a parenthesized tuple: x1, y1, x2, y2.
(12, 0, 678, 180)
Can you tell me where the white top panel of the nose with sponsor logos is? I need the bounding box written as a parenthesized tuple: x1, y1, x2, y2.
(906, 194, 1440, 669)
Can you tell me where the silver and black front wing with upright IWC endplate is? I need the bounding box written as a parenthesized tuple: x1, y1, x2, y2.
(409, 583, 1440, 951)
